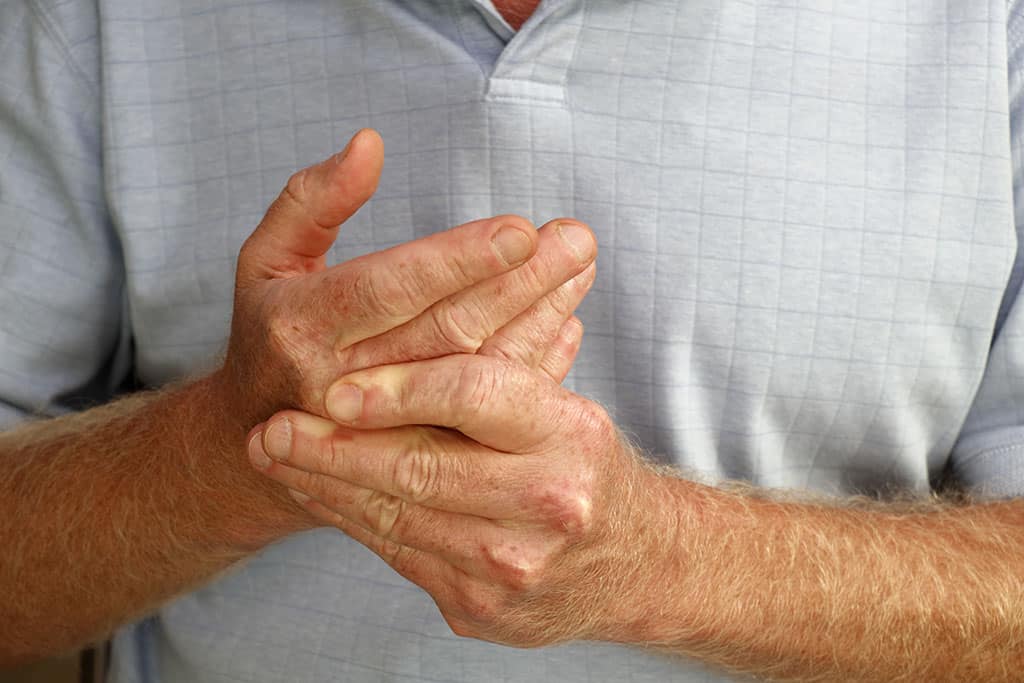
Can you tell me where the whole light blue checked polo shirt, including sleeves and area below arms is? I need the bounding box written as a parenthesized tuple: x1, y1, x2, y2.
(0, 0, 1024, 683)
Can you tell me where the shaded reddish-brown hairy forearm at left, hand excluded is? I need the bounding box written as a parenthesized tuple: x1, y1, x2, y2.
(0, 378, 303, 665)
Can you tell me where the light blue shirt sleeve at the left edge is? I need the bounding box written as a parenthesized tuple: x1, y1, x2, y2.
(0, 0, 130, 428)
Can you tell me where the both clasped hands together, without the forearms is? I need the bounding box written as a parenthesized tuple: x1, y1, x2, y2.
(221, 131, 652, 646)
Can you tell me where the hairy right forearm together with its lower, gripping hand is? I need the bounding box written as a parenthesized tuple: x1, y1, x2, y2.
(249, 355, 1024, 681)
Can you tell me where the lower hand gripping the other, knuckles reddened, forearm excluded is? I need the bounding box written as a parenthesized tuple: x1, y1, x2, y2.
(249, 355, 672, 647)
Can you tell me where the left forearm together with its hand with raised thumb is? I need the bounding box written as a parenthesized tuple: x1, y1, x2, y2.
(0, 131, 596, 667)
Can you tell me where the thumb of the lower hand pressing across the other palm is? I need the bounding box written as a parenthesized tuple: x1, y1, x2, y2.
(325, 354, 589, 454)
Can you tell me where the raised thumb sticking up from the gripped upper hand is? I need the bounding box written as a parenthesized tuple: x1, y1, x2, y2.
(238, 128, 384, 286)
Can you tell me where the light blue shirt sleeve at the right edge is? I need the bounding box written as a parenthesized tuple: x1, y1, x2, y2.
(948, 0, 1024, 498)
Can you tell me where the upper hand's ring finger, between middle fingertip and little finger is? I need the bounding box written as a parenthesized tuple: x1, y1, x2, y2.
(475, 264, 596, 368)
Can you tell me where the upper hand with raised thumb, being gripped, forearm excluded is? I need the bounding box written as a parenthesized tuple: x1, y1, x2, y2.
(218, 130, 596, 425)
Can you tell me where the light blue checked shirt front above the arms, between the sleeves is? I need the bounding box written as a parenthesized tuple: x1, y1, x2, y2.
(104, 0, 1014, 491)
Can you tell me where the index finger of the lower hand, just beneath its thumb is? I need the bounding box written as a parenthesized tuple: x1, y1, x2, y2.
(251, 411, 537, 519)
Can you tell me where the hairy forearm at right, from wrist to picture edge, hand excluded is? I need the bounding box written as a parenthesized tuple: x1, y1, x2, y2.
(620, 475, 1024, 681)
